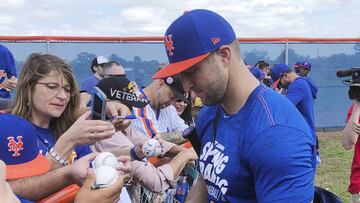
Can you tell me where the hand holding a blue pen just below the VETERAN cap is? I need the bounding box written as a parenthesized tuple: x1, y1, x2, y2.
(106, 101, 131, 131)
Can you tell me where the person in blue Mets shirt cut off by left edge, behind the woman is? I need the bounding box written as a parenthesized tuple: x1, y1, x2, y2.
(0, 44, 17, 99)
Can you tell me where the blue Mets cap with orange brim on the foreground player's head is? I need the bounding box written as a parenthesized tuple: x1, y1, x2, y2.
(153, 9, 236, 79)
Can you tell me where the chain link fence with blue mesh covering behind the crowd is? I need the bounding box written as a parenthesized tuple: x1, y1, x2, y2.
(0, 40, 360, 129)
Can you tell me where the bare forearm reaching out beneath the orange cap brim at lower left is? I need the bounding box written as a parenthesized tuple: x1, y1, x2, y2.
(9, 166, 72, 201)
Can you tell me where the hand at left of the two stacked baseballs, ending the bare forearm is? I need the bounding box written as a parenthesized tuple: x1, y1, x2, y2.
(70, 152, 98, 186)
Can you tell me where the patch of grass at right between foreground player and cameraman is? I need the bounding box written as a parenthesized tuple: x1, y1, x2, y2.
(315, 132, 353, 202)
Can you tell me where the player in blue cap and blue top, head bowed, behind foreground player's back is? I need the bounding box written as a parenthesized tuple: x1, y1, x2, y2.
(270, 64, 321, 164)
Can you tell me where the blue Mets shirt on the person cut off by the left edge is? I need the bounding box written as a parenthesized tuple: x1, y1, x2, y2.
(0, 44, 17, 98)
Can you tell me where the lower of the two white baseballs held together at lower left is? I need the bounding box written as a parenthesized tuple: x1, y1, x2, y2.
(94, 165, 119, 187)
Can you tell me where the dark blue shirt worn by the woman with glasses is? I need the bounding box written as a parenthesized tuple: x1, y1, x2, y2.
(34, 125, 92, 164)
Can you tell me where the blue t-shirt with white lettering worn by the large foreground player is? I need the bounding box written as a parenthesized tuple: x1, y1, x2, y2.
(196, 85, 316, 202)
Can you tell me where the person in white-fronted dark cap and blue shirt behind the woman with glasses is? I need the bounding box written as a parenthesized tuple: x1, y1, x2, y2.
(81, 56, 109, 94)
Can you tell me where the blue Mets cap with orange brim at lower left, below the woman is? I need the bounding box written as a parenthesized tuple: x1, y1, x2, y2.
(0, 114, 51, 180)
